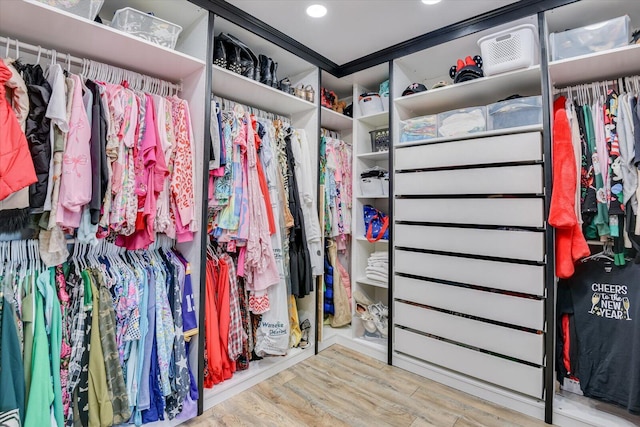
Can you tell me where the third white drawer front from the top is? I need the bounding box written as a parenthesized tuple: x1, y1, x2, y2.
(393, 199, 544, 227)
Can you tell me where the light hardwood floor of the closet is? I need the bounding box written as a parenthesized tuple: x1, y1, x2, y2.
(183, 345, 546, 427)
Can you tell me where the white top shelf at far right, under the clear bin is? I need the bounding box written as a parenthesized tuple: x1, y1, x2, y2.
(549, 45, 640, 88)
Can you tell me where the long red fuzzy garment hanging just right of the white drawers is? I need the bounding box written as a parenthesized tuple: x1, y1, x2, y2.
(549, 96, 590, 279)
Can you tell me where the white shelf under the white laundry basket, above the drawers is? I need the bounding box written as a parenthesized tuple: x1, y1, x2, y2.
(394, 65, 542, 120)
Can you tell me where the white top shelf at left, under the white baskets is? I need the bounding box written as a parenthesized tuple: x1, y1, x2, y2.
(0, 0, 205, 82)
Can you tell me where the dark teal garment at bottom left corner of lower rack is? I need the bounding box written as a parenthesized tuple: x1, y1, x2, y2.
(0, 297, 25, 423)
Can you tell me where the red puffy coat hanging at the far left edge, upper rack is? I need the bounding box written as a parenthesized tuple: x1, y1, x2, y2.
(0, 59, 37, 200)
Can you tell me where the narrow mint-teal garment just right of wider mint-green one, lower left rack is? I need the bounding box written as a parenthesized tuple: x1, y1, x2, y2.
(43, 267, 64, 426)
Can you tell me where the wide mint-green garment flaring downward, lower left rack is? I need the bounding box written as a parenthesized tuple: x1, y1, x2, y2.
(23, 274, 54, 427)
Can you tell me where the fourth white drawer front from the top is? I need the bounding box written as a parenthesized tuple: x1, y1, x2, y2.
(393, 224, 544, 262)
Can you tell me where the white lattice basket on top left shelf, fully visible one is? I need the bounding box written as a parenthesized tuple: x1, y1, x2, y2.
(111, 7, 182, 49)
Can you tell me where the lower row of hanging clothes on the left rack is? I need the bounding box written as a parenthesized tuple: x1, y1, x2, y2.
(0, 241, 198, 426)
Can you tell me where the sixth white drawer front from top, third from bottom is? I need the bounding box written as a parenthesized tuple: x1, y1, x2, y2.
(393, 276, 544, 331)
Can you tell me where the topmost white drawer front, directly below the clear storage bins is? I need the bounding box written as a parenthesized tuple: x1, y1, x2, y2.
(395, 132, 542, 170)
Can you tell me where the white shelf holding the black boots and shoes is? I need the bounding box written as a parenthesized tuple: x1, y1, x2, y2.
(212, 65, 316, 116)
